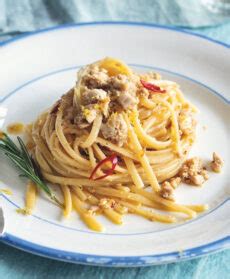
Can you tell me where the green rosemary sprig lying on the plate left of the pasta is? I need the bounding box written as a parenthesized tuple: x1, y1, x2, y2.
(0, 133, 63, 207)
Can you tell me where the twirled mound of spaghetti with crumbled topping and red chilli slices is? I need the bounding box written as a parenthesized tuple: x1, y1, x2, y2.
(27, 58, 206, 231)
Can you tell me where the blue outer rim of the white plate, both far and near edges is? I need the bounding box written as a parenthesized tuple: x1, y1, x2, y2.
(0, 21, 230, 266)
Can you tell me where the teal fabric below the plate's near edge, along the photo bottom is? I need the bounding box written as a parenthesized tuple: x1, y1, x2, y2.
(0, 243, 230, 279)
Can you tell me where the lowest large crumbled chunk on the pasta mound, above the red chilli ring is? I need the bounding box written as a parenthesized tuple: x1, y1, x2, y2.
(101, 113, 128, 146)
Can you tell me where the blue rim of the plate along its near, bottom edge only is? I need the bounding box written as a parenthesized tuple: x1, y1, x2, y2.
(0, 233, 230, 267)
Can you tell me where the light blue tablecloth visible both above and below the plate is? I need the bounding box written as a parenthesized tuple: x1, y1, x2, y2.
(0, 0, 230, 279)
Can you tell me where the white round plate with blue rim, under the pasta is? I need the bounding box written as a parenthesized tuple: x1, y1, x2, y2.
(0, 23, 230, 266)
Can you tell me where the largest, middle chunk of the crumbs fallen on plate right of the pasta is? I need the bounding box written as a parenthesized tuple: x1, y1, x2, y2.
(179, 157, 208, 186)
